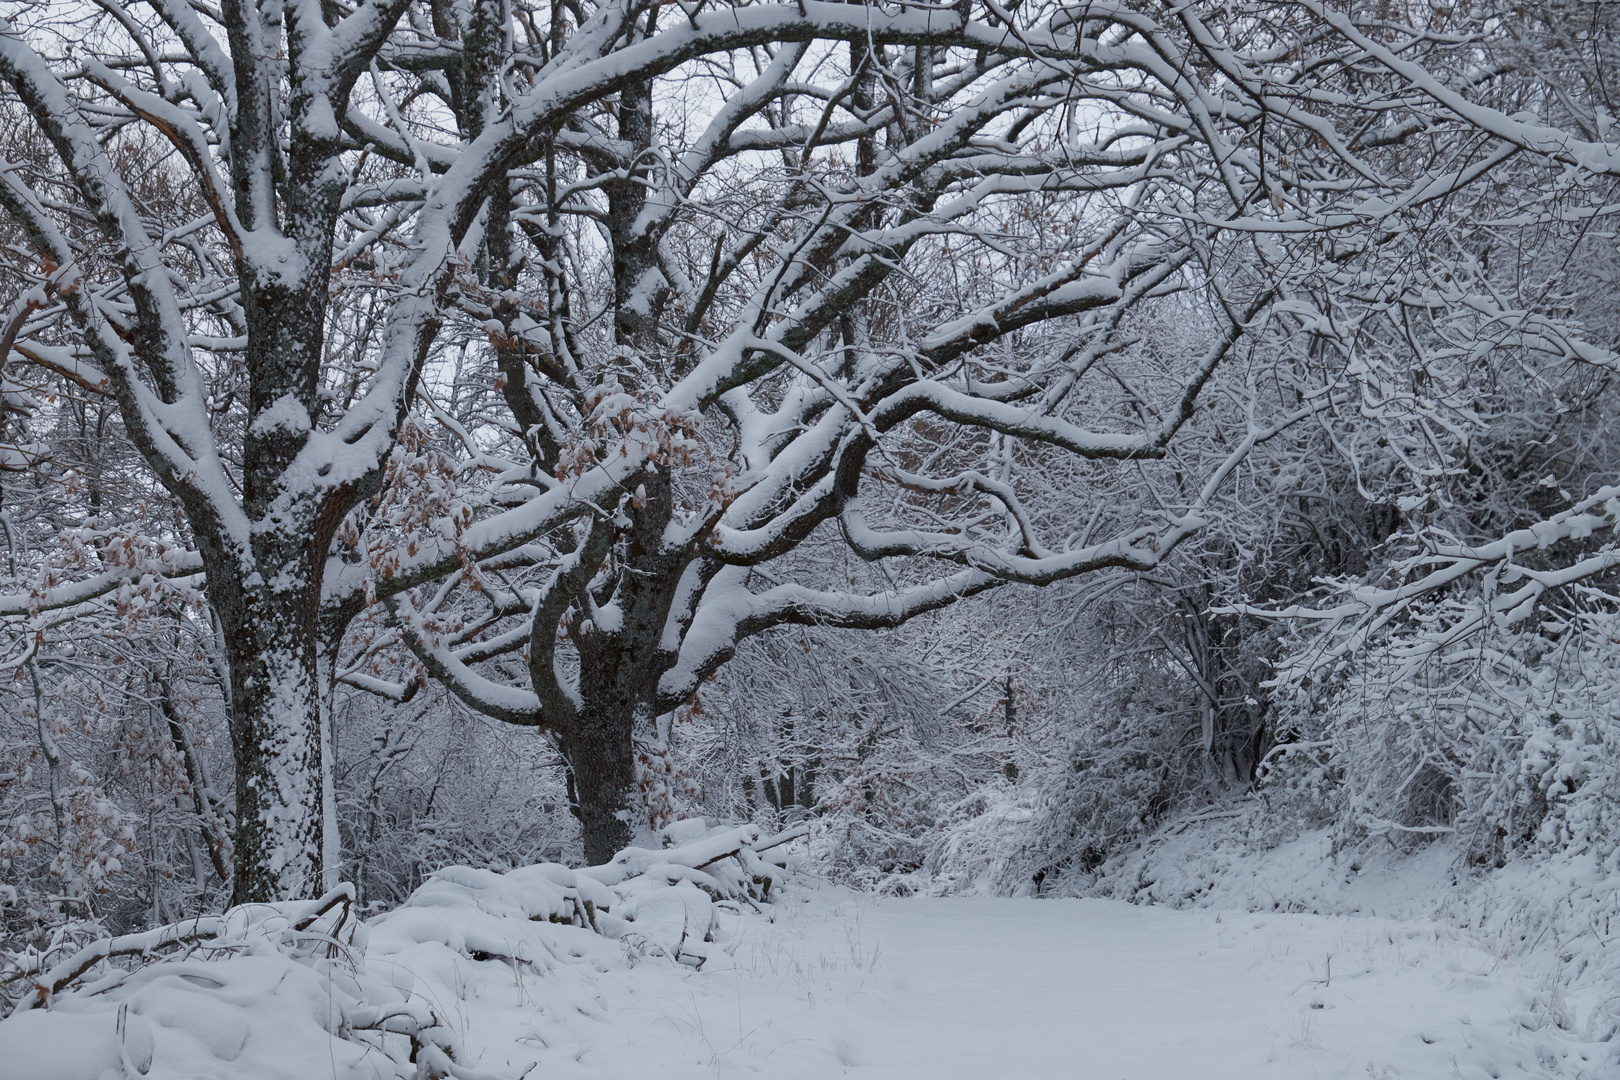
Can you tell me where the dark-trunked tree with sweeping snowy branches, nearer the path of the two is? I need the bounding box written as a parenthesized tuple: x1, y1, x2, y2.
(364, 6, 1448, 858)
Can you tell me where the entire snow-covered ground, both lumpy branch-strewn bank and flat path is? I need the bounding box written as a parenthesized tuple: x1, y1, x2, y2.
(0, 827, 1620, 1080)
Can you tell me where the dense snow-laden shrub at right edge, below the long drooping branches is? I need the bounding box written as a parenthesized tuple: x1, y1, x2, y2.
(1260, 594, 1620, 865)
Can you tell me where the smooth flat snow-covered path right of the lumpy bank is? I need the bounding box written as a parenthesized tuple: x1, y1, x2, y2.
(498, 895, 1604, 1080)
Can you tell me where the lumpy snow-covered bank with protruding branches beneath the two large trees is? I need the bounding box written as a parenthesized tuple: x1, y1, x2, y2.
(0, 821, 800, 1080)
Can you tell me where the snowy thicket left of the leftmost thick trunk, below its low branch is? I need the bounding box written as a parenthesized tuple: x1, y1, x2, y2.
(0, 563, 230, 942)
